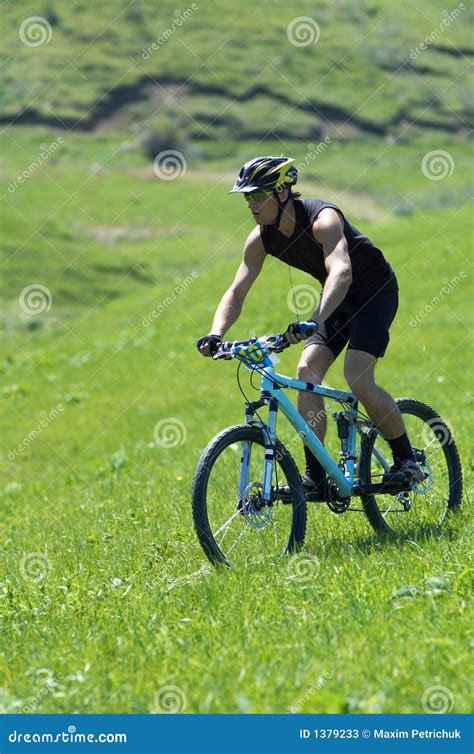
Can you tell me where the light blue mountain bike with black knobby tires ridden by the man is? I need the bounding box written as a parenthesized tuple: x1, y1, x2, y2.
(192, 322, 462, 565)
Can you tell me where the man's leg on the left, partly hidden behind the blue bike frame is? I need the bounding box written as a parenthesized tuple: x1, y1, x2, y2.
(297, 343, 334, 484)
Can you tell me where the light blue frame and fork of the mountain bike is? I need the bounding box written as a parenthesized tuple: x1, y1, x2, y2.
(237, 357, 357, 502)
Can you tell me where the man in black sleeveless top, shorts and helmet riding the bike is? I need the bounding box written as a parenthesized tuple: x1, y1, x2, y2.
(198, 157, 423, 490)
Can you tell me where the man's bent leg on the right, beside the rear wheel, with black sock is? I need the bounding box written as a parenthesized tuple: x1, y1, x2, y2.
(344, 349, 423, 481)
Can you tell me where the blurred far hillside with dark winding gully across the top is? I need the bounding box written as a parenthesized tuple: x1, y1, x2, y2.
(0, 0, 473, 142)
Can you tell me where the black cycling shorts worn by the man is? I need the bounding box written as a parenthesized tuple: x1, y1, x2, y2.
(304, 277, 398, 358)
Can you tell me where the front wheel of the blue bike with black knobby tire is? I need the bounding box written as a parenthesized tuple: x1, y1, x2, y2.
(192, 424, 306, 566)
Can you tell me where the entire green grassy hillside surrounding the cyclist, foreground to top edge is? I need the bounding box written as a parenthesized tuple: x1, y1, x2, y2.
(0, 0, 474, 713)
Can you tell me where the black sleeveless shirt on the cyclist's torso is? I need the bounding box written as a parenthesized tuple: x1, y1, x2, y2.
(260, 199, 395, 298)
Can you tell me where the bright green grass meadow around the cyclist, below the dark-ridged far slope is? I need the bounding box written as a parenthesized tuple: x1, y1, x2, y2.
(0, 125, 473, 713)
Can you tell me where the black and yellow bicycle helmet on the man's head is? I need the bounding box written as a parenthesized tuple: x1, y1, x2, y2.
(229, 157, 298, 194)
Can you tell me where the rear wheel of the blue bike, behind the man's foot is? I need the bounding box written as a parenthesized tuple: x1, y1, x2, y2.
(359, 398, 462, 535)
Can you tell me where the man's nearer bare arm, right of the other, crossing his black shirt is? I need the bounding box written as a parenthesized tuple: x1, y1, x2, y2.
(311, 207, 352, 322)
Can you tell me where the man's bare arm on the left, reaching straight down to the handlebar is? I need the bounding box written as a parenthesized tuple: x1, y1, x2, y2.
(199, 227, 267, 356)
